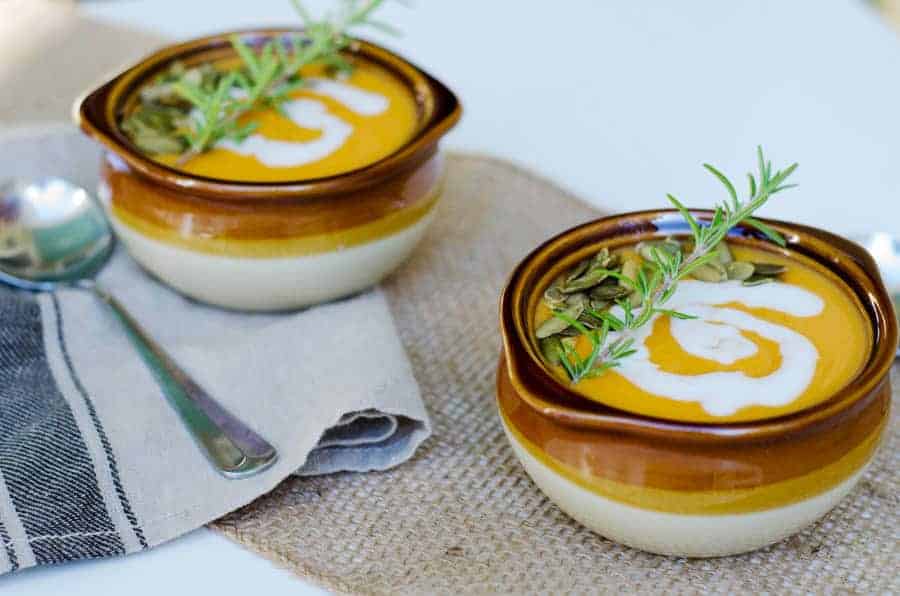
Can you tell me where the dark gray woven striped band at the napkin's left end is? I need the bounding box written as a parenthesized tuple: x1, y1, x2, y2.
(0, 288, 135, 571)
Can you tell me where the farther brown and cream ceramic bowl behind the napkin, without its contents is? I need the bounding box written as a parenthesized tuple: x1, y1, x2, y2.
(75, 29, 461, 310)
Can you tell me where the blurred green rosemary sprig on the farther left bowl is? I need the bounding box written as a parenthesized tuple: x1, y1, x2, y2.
(171, 0, 394, 165)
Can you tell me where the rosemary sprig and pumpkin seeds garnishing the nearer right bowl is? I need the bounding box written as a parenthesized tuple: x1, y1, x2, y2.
(536, 147, 797, 384)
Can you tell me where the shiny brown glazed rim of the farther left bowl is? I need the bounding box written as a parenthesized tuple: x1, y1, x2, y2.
(73, 27, 462, 200)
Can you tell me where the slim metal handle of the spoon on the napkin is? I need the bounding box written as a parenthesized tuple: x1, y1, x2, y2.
(90, 285, 278, 478)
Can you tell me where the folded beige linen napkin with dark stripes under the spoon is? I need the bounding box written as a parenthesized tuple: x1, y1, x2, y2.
(0, 127, 430, 572)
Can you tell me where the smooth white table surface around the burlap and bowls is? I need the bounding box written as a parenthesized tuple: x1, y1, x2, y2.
(7, 0, 900, 596)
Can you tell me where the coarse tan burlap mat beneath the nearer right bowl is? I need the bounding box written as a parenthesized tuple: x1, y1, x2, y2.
(209, 155, 900, 594)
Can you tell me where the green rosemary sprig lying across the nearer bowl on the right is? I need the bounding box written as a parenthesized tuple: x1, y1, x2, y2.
(553, 147, 798, 384)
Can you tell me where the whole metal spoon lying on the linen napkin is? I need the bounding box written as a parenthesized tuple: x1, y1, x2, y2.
(0, 178, 278, 478)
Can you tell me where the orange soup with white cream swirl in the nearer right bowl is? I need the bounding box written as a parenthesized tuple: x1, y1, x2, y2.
(534, 246, 872, 422)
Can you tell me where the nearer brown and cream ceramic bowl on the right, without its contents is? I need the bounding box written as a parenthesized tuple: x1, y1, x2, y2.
(497, 211, 897, 556)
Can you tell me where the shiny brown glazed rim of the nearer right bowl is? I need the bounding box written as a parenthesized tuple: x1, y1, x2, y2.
(500, 209, 897, 442)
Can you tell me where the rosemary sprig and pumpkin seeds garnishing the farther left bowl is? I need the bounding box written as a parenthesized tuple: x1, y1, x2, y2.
(122, 0, 395, 165)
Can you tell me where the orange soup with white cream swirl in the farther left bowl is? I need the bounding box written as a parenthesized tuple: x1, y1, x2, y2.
(153, 60, 419, 182)
